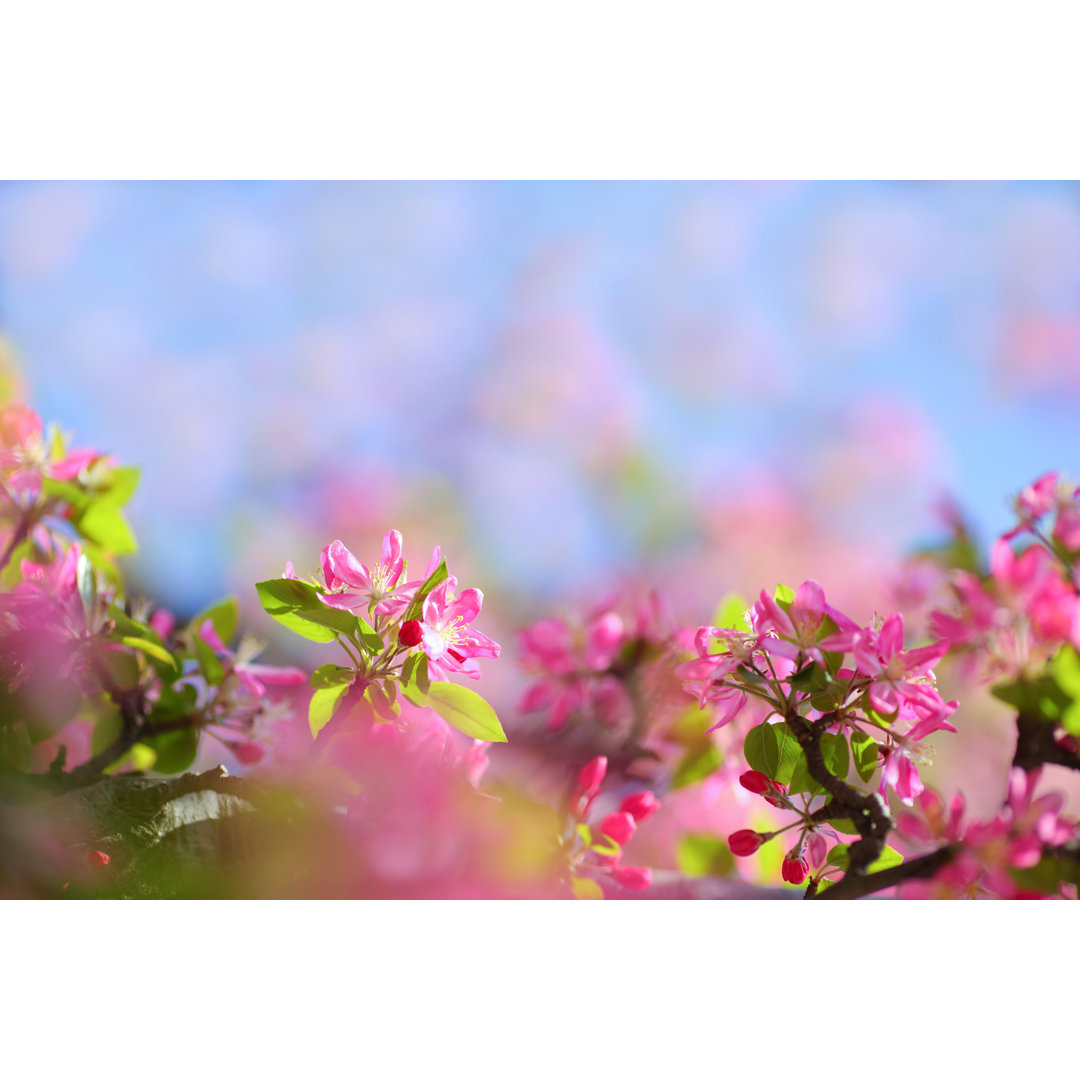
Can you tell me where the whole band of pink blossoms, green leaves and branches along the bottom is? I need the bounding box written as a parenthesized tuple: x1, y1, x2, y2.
(0, 393, 1080, 900)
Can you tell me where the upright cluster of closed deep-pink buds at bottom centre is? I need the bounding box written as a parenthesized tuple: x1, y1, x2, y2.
(563, 756, 660, 894)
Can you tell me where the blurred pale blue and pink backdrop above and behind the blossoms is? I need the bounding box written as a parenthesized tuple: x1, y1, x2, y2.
(0, 183, 1080, 877)
